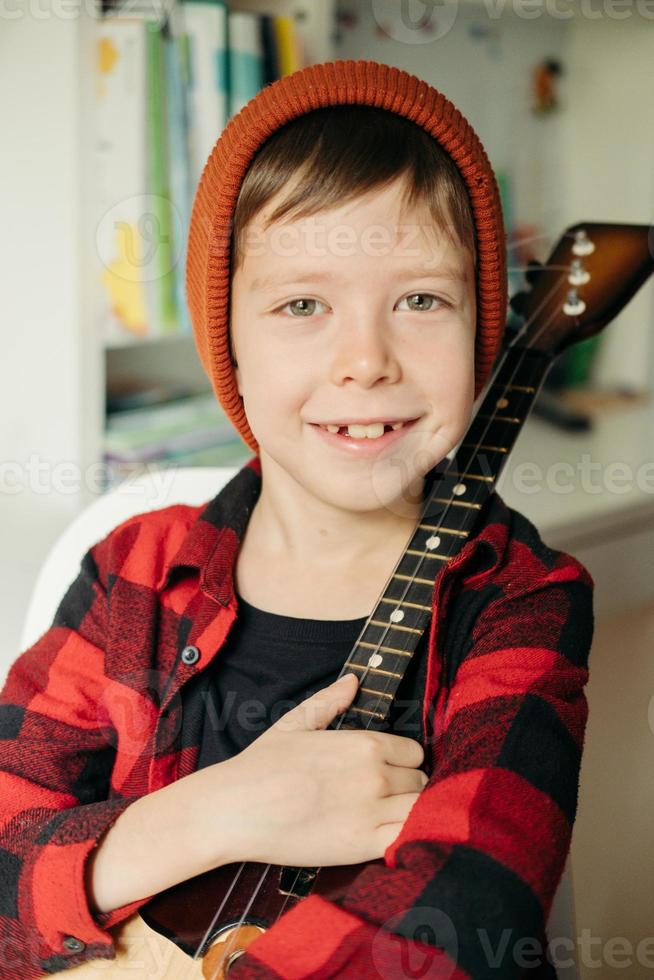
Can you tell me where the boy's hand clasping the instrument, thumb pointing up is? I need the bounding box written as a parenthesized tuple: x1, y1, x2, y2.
(208, 674, 427, 867)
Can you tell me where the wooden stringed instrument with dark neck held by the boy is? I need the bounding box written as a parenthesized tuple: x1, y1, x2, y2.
(48, 222, 654, 980)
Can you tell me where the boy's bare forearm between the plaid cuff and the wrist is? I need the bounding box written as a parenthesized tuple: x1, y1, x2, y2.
(86, 760, 241, 913)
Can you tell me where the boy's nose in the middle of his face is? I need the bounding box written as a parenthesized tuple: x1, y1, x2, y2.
(330, 317, 400, 388)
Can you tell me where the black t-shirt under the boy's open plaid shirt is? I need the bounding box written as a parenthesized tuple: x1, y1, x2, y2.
(196, 593, 428, 769)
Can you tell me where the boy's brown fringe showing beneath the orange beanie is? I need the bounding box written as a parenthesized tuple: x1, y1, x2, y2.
(230, 104, 477, 276)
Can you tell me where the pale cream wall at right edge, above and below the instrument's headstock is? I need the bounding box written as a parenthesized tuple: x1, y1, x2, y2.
(562, 16, 654, 389)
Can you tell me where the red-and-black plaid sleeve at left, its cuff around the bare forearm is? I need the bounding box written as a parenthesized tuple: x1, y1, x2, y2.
(0, 535, 155, 980)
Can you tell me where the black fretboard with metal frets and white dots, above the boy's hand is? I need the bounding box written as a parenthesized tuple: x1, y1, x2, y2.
(336, 347, 552, 730)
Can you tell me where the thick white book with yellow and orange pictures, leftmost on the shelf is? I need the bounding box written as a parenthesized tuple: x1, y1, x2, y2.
(95, 13, 177, 346)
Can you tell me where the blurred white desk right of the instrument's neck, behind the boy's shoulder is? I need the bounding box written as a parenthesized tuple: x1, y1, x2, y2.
(497, 399, 654, 616)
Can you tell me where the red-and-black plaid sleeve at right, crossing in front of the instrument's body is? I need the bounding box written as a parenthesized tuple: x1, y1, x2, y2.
(230, 552, 593, 980)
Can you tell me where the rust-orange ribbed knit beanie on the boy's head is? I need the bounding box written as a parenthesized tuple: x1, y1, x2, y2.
(186, 60, 507, 453)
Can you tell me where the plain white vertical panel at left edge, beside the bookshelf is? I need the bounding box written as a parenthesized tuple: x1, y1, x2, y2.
(0, 2, 102, 663)
